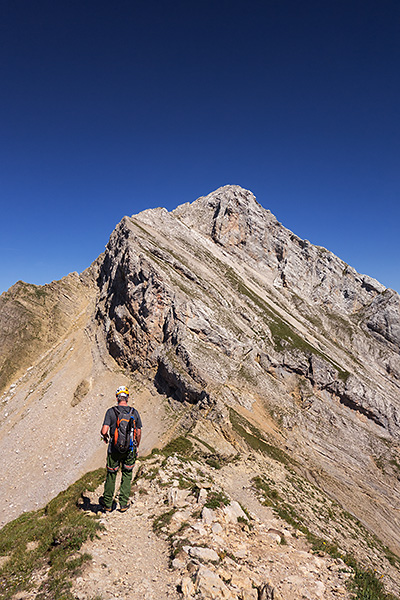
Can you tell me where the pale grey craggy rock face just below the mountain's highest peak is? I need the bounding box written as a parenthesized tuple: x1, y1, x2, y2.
(173, 186, 385, 313)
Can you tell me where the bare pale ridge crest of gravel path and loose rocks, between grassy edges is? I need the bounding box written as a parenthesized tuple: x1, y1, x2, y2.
(73, 456, 351, 600)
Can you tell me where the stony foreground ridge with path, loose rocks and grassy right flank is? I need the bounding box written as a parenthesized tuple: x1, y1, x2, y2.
(67, 425, 400, 600)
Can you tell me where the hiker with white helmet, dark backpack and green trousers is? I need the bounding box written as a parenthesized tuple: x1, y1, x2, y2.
(99, 386, 142, 512)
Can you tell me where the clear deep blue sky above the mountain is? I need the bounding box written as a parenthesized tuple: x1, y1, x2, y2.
(0, 0, 400, 292)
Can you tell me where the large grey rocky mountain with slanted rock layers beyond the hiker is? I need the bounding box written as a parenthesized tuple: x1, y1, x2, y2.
(2, 186, 400, 564)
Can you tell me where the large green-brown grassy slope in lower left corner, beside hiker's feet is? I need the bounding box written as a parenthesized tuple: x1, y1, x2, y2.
(0, 469, 105, 600)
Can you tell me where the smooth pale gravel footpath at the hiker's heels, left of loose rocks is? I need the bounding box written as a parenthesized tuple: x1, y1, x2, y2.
(74, 468, 181, 600)
